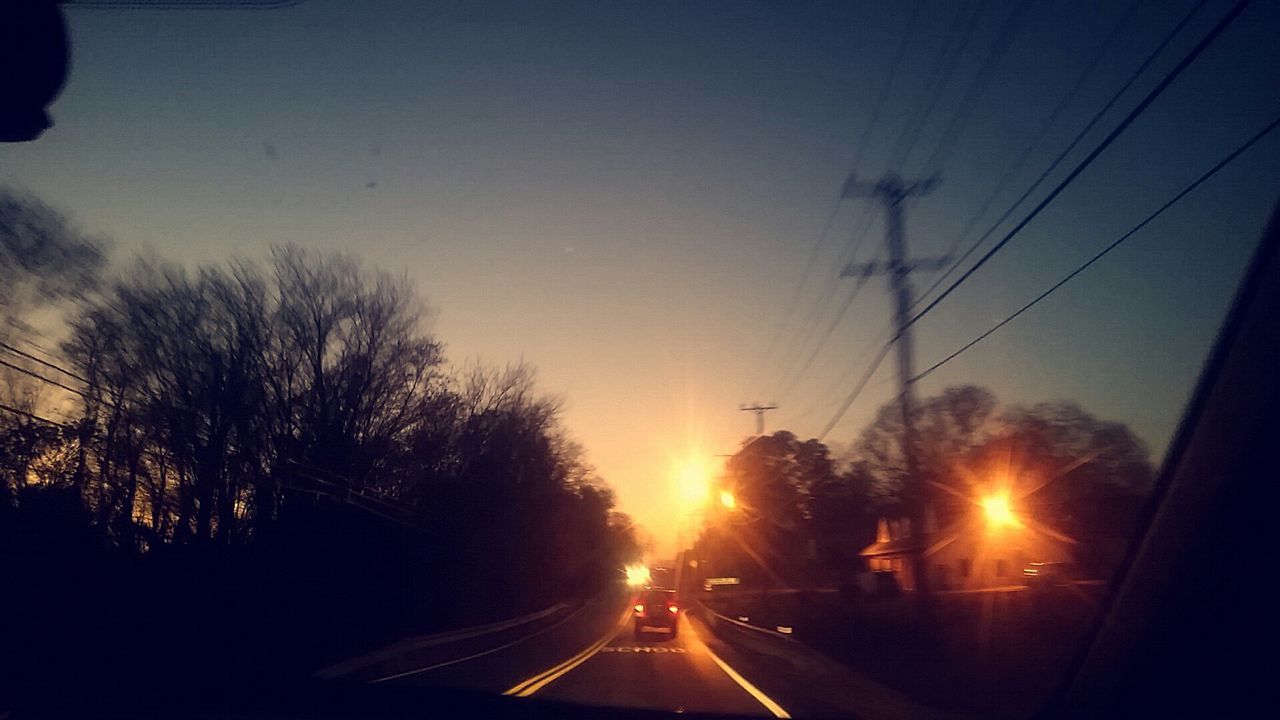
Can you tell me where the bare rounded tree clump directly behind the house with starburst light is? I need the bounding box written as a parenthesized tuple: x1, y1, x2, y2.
(849, 386, 1155, 571)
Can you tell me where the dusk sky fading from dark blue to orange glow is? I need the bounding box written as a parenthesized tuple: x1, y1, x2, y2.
(0, 0, 1280, 555)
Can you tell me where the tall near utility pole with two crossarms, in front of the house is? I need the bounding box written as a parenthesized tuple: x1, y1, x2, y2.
(840, 173, 951, 621)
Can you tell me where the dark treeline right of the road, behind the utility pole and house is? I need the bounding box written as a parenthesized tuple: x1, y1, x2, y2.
(696, 386, 1155, 587)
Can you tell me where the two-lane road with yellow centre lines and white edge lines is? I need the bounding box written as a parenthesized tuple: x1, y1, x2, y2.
(355, 593, 790, 717)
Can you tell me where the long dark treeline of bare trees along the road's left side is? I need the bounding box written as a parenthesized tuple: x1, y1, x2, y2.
(0, 188, 637, 691)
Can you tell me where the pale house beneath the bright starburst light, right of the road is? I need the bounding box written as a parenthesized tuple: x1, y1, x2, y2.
(859, 507, 1074, 591)
